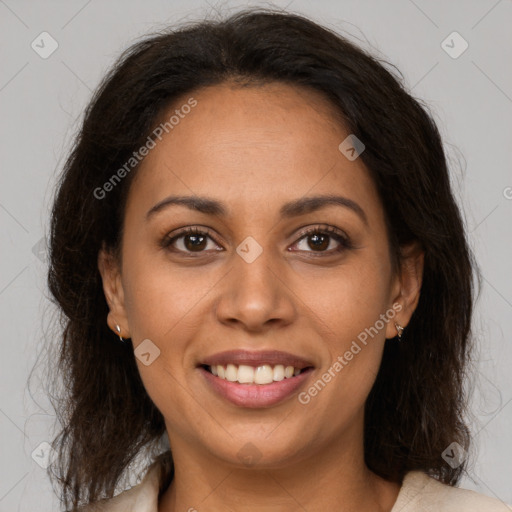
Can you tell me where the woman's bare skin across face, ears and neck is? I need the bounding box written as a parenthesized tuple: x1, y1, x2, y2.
(98, 83, 423, 512)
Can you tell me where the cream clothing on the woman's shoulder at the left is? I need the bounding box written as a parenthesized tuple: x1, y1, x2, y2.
(72, 463, 161, 512)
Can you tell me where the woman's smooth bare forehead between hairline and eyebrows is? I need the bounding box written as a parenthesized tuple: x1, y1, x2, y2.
(124, 83, 376, 220)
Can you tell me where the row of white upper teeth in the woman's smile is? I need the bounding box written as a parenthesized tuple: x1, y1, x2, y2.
(209, 363, 301, 384)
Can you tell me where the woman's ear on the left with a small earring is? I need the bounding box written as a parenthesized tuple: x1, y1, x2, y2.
(98, 245, 130, 338)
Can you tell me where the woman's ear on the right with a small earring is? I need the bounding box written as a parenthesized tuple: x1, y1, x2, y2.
(386, 242, 425, 338)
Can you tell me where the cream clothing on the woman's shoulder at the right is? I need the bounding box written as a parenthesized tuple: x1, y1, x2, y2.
(391, 471, 511, 512)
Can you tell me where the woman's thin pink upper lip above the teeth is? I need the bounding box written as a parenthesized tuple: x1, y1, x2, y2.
(201, 350, 313, 370)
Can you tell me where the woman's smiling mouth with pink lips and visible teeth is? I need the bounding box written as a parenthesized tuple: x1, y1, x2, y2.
(198, 350, 314, 408)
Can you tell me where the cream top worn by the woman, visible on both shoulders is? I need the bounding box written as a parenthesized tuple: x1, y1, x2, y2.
(79, 463, 512, 512)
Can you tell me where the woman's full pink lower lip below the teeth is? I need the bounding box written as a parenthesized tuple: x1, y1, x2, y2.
(198, 367, 313, 408)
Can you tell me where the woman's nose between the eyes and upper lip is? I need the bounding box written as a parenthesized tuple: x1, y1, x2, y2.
(216, 244, 297, 332)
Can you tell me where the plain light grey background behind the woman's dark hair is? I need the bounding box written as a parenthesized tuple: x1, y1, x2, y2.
(0, 0, 512, 512)
